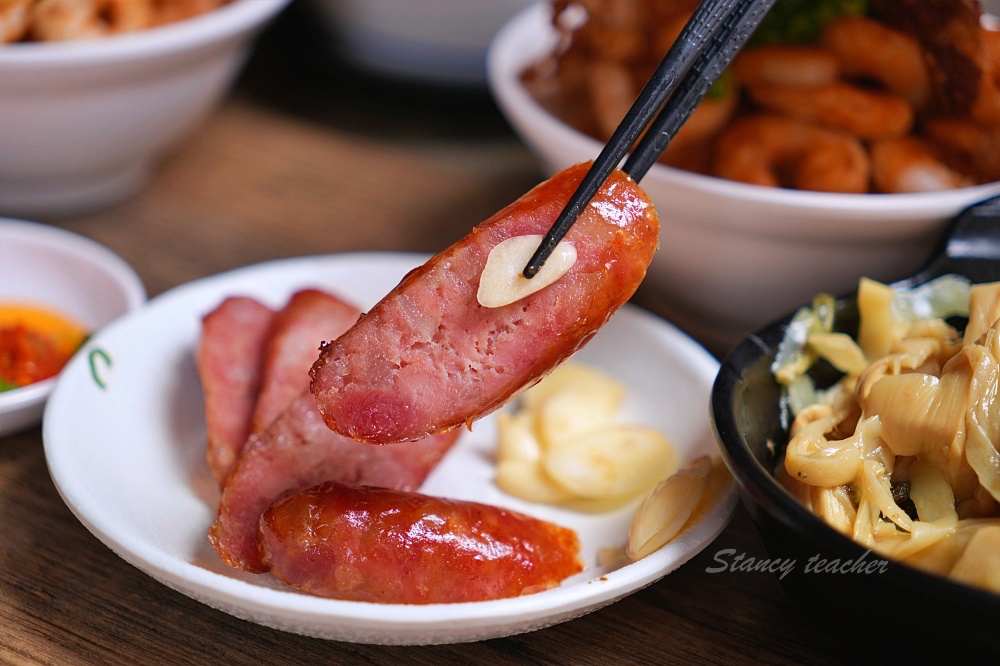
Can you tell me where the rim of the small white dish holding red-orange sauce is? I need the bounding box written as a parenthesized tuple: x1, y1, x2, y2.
(0, 217, 146, 413)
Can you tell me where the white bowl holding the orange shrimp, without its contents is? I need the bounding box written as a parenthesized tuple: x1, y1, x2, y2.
(487, 3, 1000, 347)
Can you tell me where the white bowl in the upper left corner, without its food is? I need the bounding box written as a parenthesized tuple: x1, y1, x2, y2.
(0, 0, 289, 219)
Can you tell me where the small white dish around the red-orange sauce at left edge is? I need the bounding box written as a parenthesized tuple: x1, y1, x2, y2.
(0, 218, 146, 437)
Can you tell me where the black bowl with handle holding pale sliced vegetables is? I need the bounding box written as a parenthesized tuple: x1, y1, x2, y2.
(711, 199, 1000, 656)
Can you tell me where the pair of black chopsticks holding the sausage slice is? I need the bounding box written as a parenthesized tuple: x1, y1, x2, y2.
(523, 0, 775, 278)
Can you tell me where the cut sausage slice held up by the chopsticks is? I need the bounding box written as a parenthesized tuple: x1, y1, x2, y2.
(312, 164, 659, 444)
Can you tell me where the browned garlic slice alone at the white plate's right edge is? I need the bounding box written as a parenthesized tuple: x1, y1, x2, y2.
(626, 456, 712, 560)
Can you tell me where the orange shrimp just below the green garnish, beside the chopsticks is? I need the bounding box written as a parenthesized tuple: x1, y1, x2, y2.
(731, 44, 840, 86)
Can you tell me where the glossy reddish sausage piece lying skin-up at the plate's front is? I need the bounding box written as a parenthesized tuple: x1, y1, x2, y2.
(258, 483, 583, 604)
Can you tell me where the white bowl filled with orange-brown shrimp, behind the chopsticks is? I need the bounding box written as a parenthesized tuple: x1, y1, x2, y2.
(489, 0, 1000, 350)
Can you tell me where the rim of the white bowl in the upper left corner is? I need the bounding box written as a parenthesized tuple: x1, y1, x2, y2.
(0, 0, 292, 67)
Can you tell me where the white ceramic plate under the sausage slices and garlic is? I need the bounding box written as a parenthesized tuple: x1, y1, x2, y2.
(43, 253, 736, 644)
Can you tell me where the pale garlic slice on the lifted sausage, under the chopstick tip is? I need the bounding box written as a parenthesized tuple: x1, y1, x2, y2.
(476, 235, 576, 308)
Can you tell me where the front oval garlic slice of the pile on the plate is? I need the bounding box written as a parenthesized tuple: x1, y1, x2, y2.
(542, 426, 676, 499)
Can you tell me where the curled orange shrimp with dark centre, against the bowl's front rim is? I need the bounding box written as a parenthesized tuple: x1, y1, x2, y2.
(715, 115, 871, 193)
